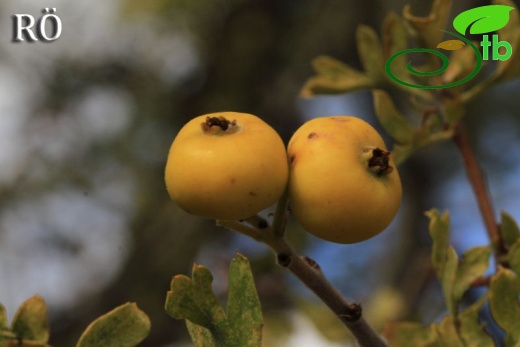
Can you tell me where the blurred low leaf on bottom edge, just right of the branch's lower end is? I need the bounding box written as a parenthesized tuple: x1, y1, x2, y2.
(383, 322, 440, 347)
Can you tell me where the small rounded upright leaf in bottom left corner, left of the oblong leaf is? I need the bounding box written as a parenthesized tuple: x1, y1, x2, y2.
(11, 295, 49, 344)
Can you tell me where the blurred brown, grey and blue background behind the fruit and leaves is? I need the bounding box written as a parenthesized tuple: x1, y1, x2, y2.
(0, 0, 520, 347)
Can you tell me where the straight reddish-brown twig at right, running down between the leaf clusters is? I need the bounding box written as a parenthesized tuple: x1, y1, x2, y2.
(453, 123, 505, 259)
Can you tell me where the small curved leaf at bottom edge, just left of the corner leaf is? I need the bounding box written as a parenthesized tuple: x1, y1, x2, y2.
(458, 295, 495, 347)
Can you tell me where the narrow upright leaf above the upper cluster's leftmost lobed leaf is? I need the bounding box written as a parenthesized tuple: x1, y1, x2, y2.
(356, 25, 386, 84)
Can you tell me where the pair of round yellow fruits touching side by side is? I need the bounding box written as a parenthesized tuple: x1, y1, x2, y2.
(165, 112, 402, 243)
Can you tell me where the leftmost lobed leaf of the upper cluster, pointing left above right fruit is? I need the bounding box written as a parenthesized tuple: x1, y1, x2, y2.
(300, 56, 373, 97)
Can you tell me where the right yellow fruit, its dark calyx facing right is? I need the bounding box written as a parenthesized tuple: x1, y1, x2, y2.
(288, 116, 402, 243)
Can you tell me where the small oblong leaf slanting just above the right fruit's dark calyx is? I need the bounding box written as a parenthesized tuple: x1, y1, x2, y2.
(372, 89, 415, 145)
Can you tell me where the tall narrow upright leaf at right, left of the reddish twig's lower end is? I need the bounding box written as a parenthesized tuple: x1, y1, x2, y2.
(426, 209, 458, 316)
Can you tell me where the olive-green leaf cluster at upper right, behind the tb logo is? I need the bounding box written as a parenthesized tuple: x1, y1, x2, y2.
(301, 0, 520, 163)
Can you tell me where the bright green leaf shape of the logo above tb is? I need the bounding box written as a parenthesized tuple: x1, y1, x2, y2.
(453, 5, 515, 35)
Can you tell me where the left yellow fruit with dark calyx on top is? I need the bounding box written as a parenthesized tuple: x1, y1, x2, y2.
(165, 112, 289, 220)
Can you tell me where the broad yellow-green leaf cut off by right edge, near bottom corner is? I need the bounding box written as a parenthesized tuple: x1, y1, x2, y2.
(489, 267, 520, 346)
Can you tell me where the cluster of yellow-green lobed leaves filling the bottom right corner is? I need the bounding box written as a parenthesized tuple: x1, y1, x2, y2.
(385, 210, 520, 347)
